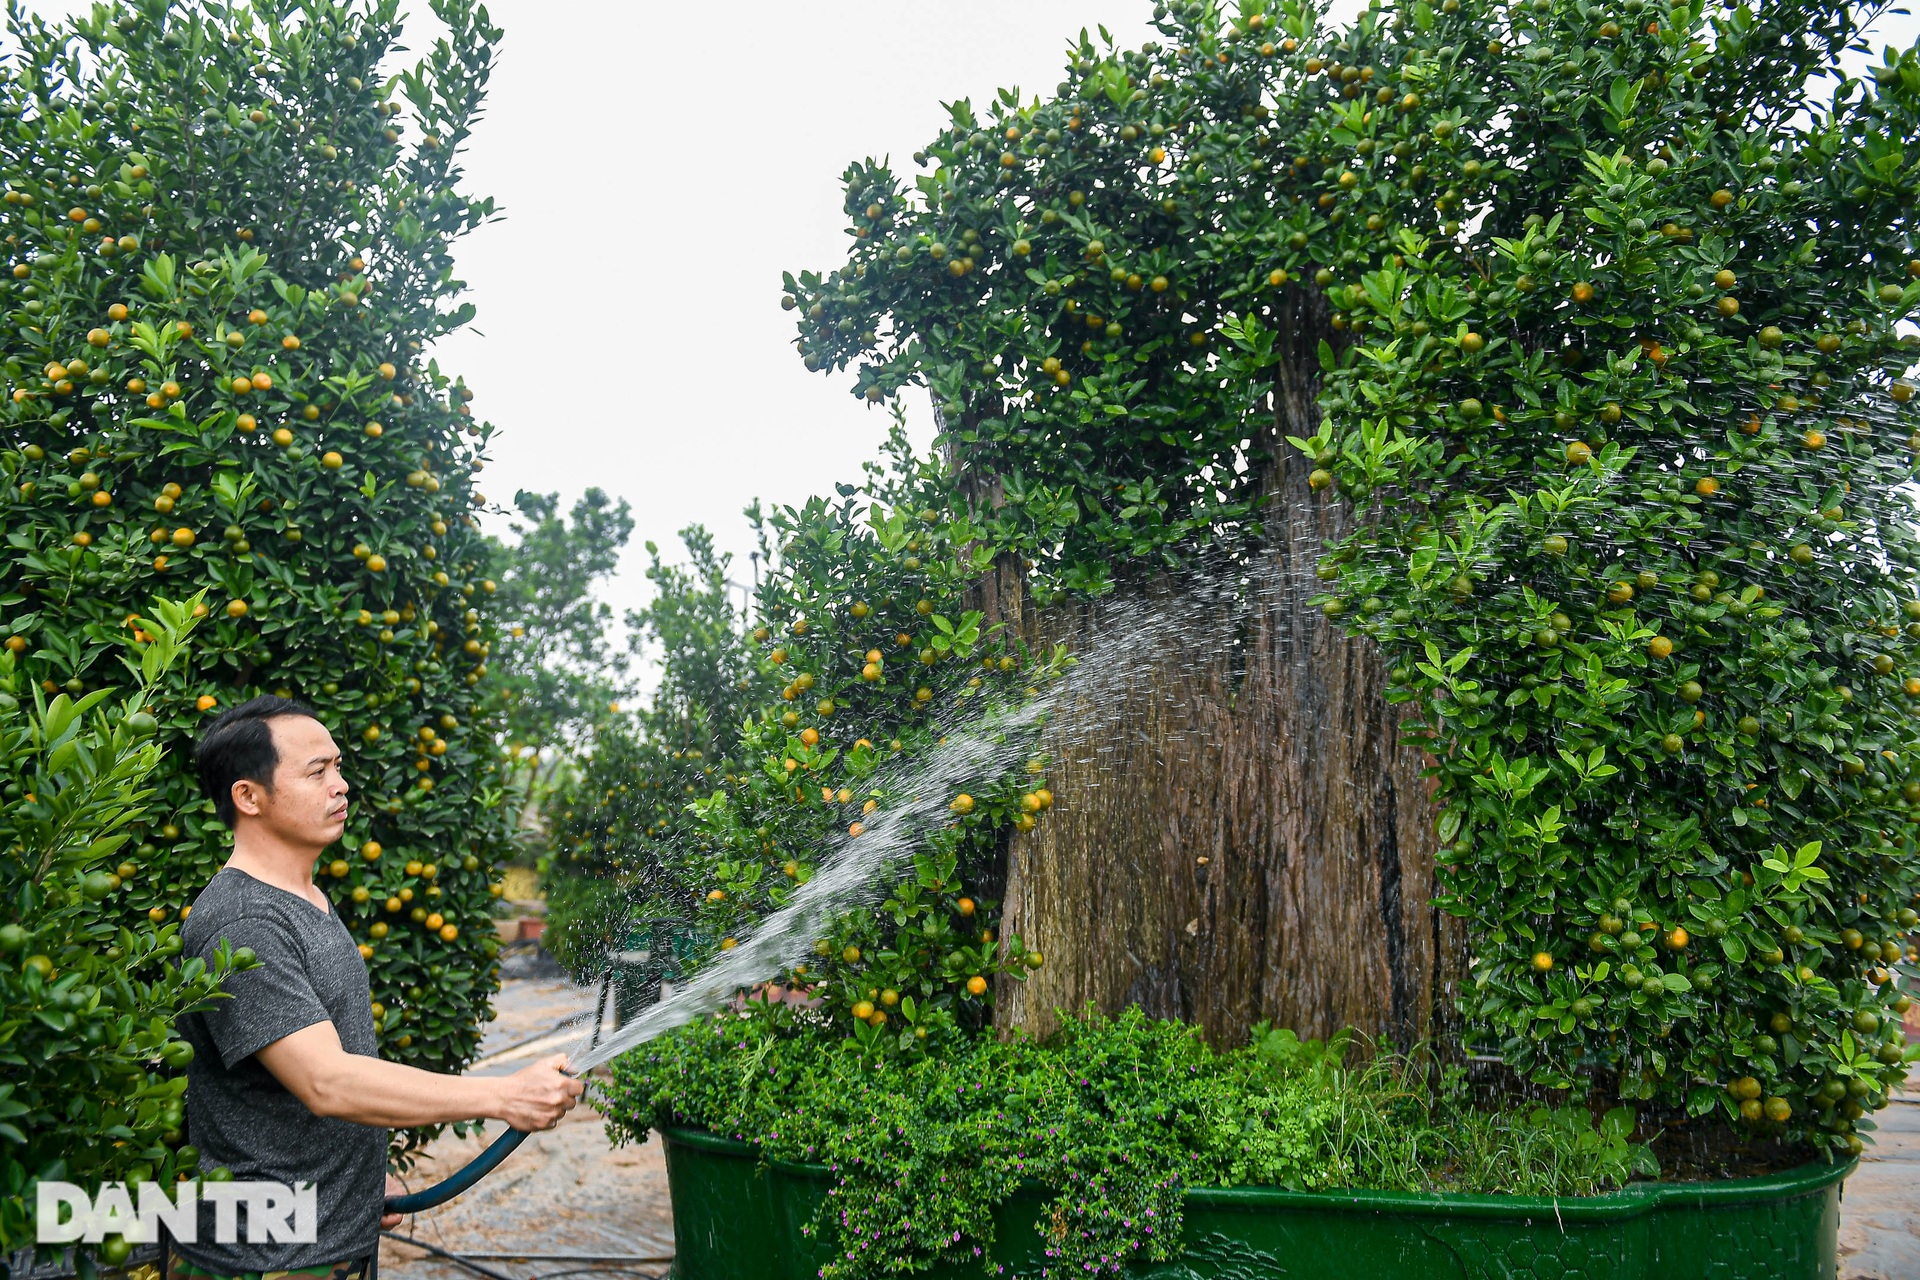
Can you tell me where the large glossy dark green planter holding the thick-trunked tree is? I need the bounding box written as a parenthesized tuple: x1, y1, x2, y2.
(660, 1128, 1853, 1280)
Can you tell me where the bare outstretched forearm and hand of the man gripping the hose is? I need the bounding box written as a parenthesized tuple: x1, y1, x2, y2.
(259, 1021, 586, 1132)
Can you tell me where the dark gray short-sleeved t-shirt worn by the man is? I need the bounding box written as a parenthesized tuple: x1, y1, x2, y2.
(179, 867, 388, 1274)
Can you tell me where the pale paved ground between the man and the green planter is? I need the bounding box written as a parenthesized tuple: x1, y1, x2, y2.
(380, 958, 1920, 1280)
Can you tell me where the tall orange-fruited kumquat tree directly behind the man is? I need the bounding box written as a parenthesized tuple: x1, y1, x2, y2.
(0, 0, 509, 1194)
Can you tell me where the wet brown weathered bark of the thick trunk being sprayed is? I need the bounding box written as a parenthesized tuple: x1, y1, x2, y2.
(977, 301, 1459, 1046)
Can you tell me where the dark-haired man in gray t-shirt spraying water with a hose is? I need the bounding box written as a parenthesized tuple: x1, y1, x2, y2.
(175, 697, 584, 1278)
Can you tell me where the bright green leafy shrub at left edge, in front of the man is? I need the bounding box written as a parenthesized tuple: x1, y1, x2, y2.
(0, 599, 259, 1263)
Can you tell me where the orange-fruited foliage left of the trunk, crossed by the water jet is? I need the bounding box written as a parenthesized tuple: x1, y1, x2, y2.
(553, 426, 1060, 1055)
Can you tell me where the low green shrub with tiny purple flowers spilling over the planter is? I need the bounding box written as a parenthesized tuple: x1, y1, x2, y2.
(599, 1009, 1653, 1280)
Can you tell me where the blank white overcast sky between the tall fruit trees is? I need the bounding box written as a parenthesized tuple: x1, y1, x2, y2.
(31, 0, 1916, 690)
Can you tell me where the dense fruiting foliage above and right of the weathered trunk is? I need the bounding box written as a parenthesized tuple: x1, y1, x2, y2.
(764, 0, 1920, 1148)
